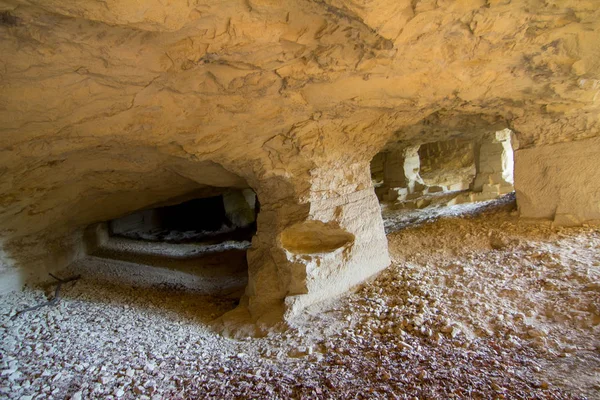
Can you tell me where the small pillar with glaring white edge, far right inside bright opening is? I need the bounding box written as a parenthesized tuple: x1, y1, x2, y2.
(471, 129, 513, 198)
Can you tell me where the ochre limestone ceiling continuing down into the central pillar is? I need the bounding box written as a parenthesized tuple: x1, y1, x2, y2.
(0, 0, 600, 322)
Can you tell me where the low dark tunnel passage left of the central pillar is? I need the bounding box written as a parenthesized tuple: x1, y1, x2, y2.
(80, 188, 259, 304)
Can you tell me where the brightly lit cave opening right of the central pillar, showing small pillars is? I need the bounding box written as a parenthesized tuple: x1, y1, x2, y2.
(370, 129, 516, 233)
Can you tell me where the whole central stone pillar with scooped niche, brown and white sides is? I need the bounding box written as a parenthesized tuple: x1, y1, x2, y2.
(226, 162, 390, 329)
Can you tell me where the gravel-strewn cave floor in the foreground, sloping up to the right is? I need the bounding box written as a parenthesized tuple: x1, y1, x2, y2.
(0, 200, 600, 399)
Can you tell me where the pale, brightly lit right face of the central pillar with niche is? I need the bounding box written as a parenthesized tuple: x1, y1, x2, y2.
(283, 162, 390, 315)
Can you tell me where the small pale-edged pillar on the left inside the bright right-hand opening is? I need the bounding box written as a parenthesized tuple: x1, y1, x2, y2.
(383, 146, 423, 200)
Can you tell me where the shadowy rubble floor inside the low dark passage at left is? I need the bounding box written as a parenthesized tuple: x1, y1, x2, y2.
(86, 237, 250, 298)
